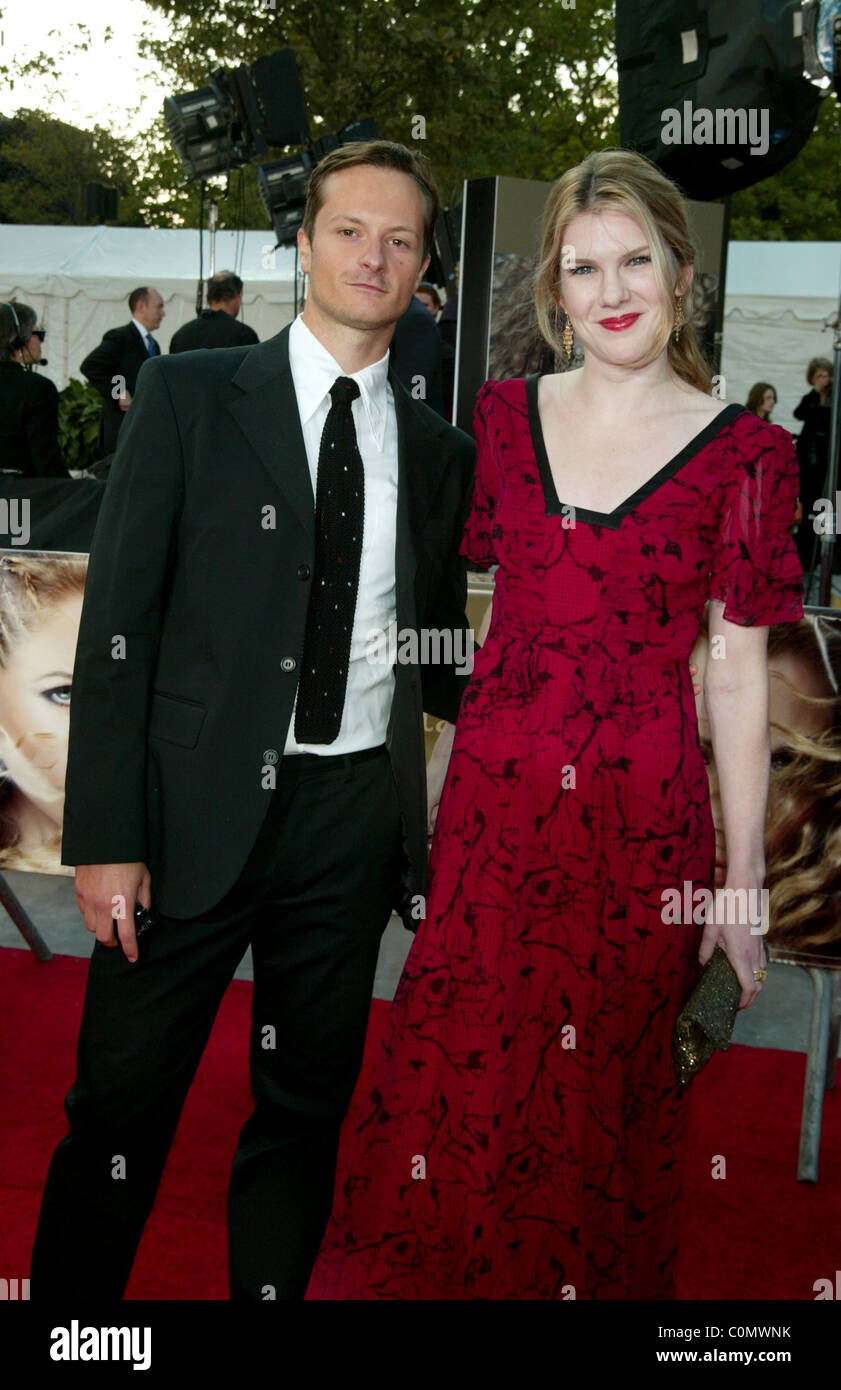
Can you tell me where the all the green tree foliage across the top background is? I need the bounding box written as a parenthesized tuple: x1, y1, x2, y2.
(0, 0, 841, 240)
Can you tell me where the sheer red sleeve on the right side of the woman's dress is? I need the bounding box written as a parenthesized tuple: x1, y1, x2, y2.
(709, 420, 803, 627)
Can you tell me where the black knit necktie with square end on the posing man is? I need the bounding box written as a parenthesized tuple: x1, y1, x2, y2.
(295, 377, 366, 744)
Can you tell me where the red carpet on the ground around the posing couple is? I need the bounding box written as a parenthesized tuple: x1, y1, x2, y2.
(0, 949, 841, 1300)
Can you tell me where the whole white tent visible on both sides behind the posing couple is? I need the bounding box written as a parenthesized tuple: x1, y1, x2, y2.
(0, 225, 841, 432)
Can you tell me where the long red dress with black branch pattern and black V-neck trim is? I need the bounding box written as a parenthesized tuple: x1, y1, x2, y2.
(310, 377, 802, 1300)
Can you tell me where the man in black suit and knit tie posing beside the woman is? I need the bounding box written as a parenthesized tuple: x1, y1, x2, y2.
(31, 142, 474, 1300)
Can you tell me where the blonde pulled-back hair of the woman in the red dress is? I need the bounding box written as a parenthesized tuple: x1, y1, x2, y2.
(535, 150, 712, 395)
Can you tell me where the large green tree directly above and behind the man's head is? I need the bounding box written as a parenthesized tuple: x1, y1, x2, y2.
(142, 0, 616, 220)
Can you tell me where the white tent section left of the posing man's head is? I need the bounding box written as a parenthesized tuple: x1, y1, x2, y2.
(0, 225, 295, 389)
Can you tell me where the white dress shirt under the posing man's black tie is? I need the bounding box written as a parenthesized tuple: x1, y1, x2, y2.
(284, 316, 398, 755)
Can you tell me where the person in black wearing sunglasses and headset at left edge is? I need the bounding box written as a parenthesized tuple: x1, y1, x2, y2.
(0, 302, 70, 478)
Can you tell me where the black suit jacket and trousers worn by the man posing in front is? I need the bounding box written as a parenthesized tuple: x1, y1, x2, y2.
(32, 329, 474, 1300)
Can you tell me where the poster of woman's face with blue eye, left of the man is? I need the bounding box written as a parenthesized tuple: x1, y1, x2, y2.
(0, 550, 88, 876)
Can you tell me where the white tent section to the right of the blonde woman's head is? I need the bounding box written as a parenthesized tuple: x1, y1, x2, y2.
(721, 242, 841, 434)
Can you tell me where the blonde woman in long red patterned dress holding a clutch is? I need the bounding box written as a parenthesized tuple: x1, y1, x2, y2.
(311, 150, 802, 1300)
